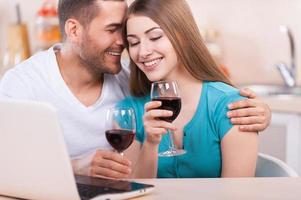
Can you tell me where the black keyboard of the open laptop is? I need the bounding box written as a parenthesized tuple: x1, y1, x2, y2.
(76, 183, 121, 200)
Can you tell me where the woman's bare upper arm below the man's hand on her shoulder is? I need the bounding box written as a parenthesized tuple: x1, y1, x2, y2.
(221, 126, 258, 177)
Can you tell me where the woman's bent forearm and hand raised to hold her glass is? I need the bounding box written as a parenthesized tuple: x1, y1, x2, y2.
(125, 101, 175, 178)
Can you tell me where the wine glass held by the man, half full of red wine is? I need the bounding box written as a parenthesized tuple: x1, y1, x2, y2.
(106, 107, 136, 156)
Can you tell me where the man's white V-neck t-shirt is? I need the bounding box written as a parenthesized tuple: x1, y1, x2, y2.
(0, 47, 129, 158)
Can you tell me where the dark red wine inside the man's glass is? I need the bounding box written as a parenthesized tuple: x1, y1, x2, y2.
(106, 129, 135, 153)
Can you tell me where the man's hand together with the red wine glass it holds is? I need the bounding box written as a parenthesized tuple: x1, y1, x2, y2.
(72, 108, 136, 179)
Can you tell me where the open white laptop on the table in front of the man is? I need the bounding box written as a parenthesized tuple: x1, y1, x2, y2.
(0, 100, 154, 200)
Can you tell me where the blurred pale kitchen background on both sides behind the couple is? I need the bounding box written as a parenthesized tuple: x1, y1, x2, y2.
(0, 0, 301, 174)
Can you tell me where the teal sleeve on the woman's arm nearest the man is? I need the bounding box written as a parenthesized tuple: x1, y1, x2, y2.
(117, 97, 145, 144)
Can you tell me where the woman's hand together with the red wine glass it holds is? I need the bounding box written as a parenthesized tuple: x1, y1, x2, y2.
(144, 81, 186, 157)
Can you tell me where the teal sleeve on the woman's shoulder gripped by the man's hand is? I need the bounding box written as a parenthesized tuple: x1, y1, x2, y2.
(213, 90, 245, 140)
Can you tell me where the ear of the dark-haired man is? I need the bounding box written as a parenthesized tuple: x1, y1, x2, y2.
(65, 19, 83, 43)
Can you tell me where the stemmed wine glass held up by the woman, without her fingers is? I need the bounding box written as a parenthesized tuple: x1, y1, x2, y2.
(151, 81, 186, 157)
